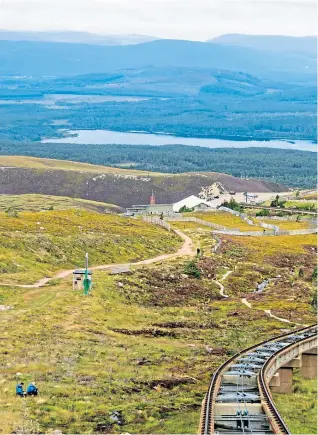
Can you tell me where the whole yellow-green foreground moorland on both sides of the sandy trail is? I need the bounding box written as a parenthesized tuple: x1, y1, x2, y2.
(0, 206, 317, 434)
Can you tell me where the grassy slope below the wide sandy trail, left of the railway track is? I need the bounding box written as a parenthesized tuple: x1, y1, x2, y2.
(0, 263, 288, 434)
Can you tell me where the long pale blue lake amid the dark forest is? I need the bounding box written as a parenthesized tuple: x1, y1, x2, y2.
(42, 130, 317, 152)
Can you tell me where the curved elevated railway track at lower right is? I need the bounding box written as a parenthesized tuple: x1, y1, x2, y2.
(199, 325, 317, 435)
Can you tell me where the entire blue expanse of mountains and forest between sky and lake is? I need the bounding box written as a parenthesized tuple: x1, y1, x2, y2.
(0, 32, 317, 146)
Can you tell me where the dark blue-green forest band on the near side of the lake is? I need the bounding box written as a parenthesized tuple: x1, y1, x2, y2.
(0, 142, 317, 188)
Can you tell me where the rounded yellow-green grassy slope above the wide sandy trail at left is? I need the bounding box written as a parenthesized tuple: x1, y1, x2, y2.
(0, 210, 181, 284)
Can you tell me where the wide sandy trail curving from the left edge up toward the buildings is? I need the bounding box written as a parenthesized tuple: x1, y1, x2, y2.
(0, 229, 196, 288)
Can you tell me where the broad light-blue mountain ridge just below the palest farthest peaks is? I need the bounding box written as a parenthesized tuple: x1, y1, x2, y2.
(0, 39, 316, 81)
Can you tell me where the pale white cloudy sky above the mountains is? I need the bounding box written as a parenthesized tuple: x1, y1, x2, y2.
(0, 0, 318, 41)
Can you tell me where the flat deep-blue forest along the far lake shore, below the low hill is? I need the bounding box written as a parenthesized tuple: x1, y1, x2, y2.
(0, 94, 317, 141)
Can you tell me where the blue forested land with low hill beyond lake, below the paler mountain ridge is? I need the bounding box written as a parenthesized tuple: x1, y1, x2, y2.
(0, 66, 317, 141)
